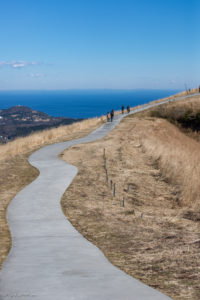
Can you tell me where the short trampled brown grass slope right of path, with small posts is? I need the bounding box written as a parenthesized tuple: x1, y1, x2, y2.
(61, 116, 200, 300)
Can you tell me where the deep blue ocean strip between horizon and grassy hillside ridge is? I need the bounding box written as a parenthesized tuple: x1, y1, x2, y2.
(0, 90, 179, 118)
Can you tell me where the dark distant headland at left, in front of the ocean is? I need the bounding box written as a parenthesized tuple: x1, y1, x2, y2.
(0, 105, 80, 143)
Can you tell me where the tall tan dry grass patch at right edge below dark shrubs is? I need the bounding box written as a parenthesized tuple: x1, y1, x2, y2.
(138, 119, 200, 208)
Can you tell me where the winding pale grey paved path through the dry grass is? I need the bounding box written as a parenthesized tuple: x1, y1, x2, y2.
(0, 95, 197, 300)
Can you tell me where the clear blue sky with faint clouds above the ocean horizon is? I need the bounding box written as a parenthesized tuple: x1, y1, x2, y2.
(0, 0, 200, 90)
